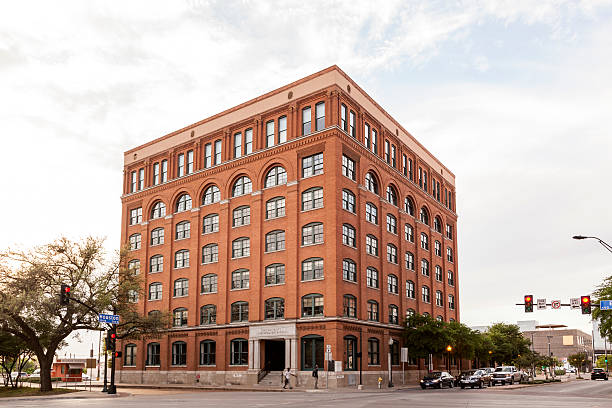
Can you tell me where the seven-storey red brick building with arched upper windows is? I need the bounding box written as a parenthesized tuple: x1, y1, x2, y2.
(118, 66, 459, 386)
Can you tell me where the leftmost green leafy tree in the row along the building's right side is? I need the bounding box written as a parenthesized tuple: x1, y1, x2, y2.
(403, 314, 450, 358)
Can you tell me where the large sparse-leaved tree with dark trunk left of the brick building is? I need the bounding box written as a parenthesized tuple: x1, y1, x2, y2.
(0, 237, 168, 391)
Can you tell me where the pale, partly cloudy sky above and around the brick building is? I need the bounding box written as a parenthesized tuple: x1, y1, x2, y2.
(0, 0, 612, 355)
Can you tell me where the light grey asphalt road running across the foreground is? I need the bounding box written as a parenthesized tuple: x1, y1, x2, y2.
(0, 381, 612, 408)
